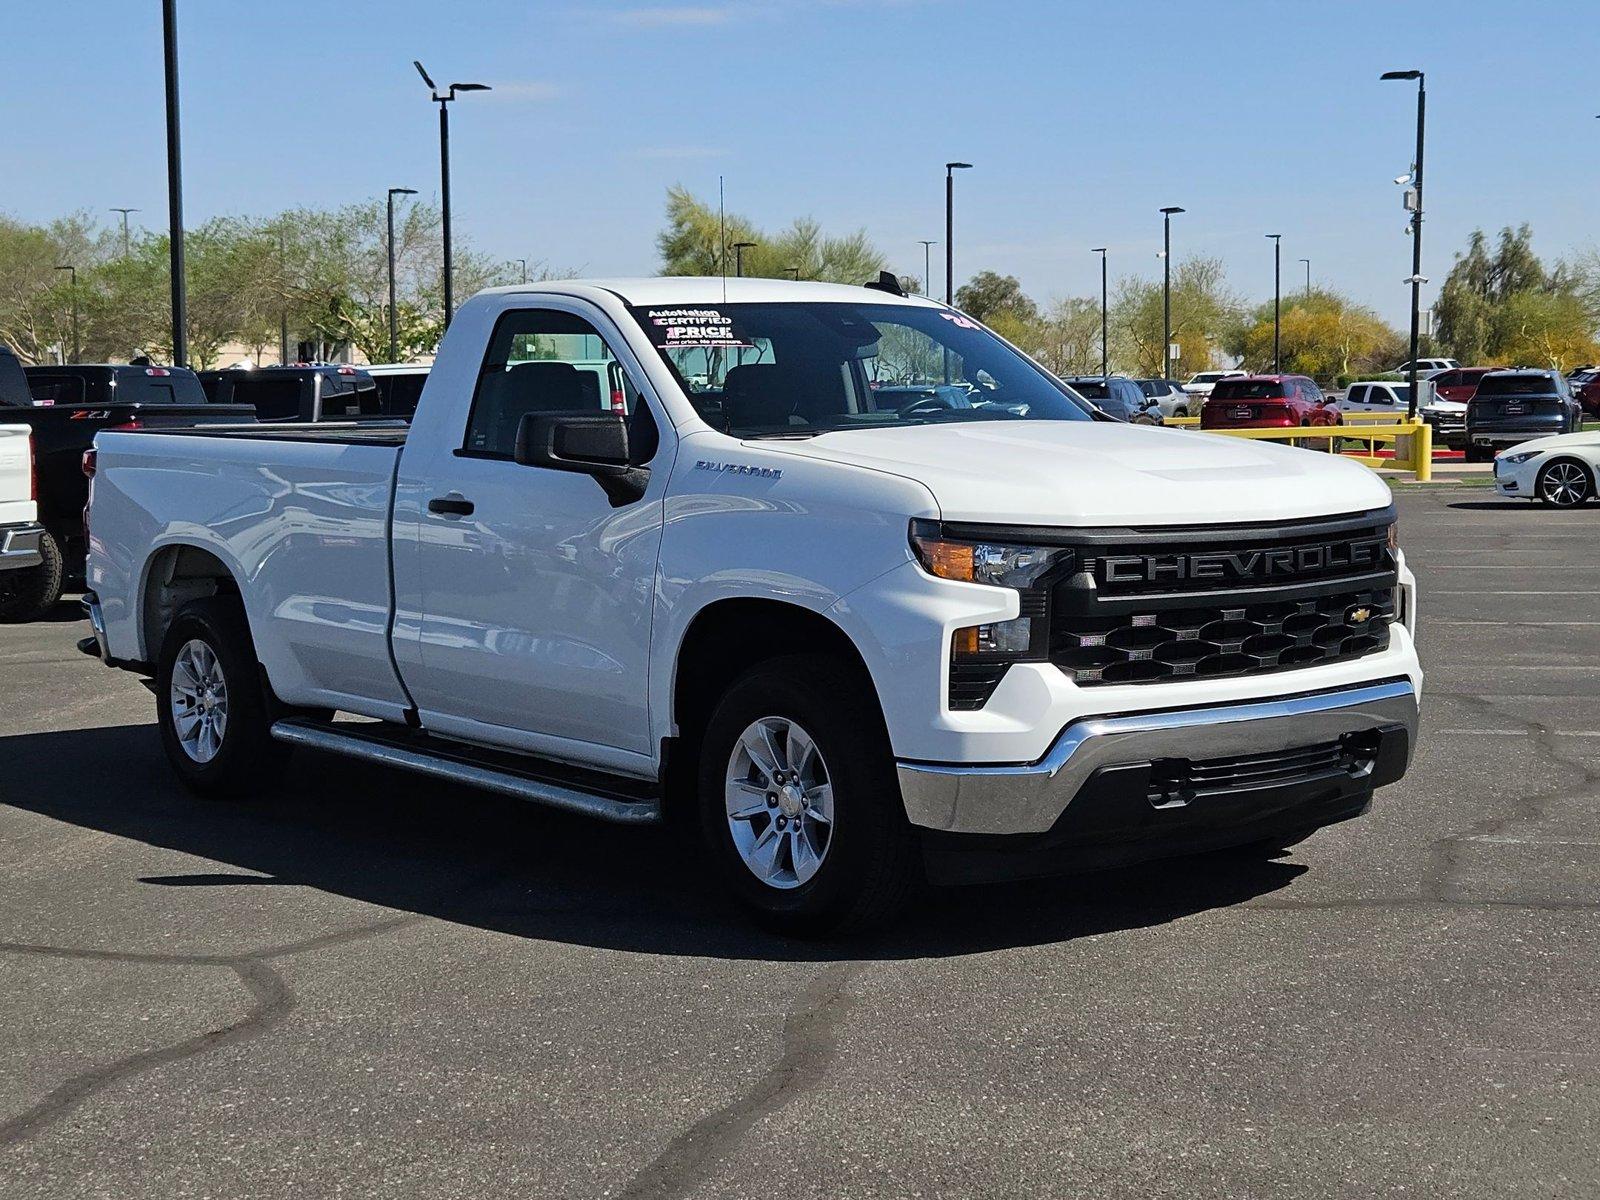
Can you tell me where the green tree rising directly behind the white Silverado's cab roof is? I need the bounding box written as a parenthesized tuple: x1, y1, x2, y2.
(656, 186, 888, 283)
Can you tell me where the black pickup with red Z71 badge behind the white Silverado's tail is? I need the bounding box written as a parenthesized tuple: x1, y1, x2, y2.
(0, 346, 256, 621)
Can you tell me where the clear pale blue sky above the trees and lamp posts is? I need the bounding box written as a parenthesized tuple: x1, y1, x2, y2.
(12, 0, 1600, 323)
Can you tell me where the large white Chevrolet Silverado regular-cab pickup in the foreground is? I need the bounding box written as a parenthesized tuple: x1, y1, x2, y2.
(86, 278, 1421, 933)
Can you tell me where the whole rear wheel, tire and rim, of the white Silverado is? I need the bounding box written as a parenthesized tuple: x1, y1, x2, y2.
(155, 595, 286, 797)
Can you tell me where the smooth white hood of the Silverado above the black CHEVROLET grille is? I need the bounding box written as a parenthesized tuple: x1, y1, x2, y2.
(760, 421, 1390, 525)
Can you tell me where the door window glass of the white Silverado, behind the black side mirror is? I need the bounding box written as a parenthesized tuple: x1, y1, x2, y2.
(461, 309, 638, 458)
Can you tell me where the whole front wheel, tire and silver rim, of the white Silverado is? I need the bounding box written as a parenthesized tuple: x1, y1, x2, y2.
(699, 656, 917, 936)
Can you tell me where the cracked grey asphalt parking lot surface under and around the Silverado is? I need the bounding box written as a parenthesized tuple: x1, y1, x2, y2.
(0, 490, 1600, 1198)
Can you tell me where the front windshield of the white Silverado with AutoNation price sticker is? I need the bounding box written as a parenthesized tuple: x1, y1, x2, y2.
(632, 302, 1093, 437)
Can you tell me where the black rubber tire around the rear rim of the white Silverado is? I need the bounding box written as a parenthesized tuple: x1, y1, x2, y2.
(155, 595, 288, 798)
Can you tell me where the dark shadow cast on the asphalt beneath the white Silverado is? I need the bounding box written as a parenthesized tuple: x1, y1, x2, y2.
(0, 725, 1306, 962)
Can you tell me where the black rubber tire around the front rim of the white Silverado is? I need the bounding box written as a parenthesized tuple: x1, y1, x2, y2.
(698, 654, 920, 938)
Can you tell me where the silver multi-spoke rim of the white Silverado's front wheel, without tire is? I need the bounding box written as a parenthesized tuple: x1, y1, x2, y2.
(723, 717, 834, 890)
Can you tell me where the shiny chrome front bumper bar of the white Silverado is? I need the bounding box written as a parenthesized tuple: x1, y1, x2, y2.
(898, 680, 1418, 834)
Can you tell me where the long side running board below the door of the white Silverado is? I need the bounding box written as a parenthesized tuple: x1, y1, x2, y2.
(272, 718, 661, 826)
